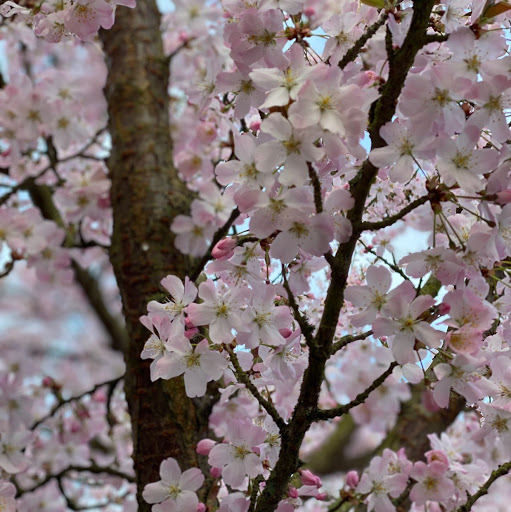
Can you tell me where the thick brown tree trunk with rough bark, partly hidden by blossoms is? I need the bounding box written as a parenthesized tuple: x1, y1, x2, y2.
(101, 0, 219, 512)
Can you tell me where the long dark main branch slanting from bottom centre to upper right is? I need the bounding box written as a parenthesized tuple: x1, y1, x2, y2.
(252, 0, 435, 512)
